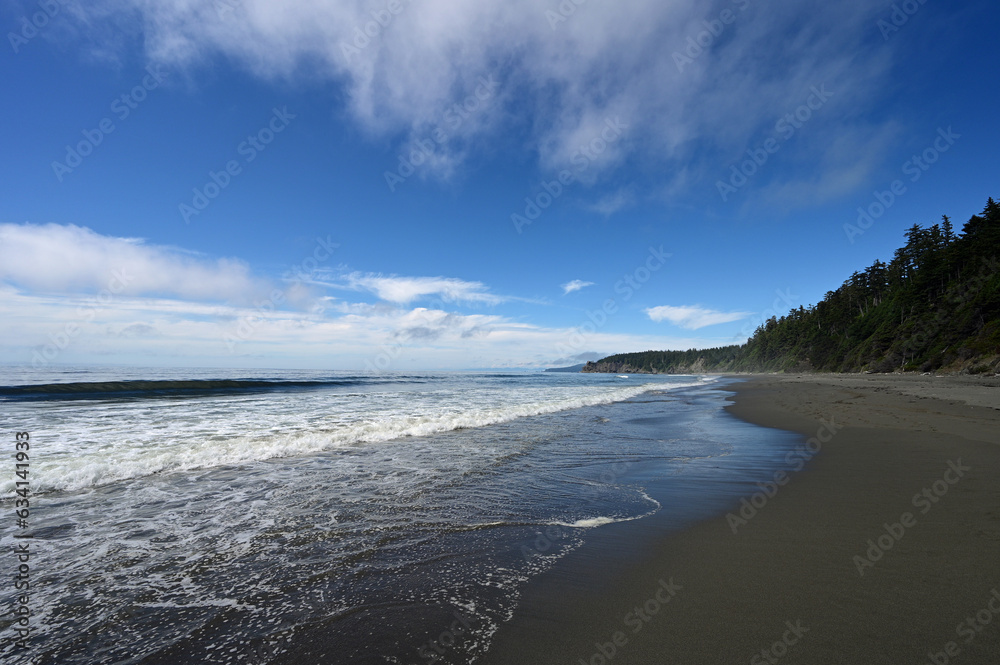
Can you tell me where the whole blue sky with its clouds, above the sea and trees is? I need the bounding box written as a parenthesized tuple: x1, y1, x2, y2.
(0, 0, 1000, 371)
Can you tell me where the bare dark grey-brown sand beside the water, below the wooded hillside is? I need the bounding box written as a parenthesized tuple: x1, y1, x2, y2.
(481, 375, 1000, 665)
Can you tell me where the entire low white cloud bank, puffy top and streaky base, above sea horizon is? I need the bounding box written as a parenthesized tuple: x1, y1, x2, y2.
(0, 224, 740, 369)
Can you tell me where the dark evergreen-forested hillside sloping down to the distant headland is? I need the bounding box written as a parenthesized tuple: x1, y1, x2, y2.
(583, 198, 1000, 374)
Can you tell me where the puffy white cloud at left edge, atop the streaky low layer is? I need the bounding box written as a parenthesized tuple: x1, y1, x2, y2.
(0, 224, 269, 302)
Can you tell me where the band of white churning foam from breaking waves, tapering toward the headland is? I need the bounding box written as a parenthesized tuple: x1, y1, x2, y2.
(0, 382, 697, 497)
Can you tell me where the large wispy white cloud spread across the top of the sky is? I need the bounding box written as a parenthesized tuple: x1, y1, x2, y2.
(64, 0, 892, 187)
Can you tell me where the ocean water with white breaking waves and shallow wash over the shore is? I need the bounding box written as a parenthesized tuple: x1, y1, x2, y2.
(0, 367, 797, 665)
